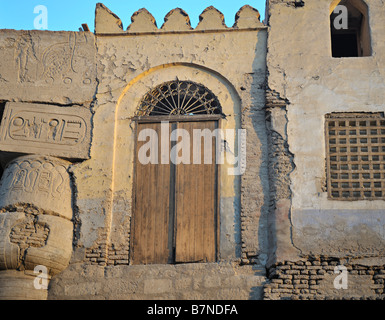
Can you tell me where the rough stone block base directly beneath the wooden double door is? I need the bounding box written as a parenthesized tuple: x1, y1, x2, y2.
(48, 263, 266, 300)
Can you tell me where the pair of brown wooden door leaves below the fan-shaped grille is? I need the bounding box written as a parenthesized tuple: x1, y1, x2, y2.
(131, 121, 218, 264)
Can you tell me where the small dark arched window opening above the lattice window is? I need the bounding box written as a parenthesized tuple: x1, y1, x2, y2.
(330, 0, 371, 58)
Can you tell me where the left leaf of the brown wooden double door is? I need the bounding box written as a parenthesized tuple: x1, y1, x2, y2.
(132, 123, 170, 264)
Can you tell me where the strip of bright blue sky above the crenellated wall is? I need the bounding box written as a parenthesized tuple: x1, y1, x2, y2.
(0, 0, 266, 31)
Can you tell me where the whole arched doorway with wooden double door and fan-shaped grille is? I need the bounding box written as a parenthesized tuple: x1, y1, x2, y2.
(130, 79, 223, 264)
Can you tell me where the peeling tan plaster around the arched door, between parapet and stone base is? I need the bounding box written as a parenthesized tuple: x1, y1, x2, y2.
(73, 22, 267, 264)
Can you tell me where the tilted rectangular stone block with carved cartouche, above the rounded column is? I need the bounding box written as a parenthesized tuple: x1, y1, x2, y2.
(0, 102, 91, 159)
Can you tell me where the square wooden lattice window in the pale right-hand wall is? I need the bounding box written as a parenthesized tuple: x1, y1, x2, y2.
(325, 113, 385, 200)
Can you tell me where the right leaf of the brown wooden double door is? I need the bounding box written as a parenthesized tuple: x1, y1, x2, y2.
(175, 121, 216, 262)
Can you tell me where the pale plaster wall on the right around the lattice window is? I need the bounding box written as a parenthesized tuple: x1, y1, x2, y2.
(267, 0, 385, 263)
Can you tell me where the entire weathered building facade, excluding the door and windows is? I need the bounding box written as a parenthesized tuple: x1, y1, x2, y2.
(0, 0, 385, 299)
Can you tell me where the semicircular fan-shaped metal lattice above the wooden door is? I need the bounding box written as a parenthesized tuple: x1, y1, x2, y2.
(136, 80, 222, 116)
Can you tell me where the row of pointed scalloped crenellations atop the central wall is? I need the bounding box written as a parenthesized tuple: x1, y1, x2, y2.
(95, 3, 265, 34)
